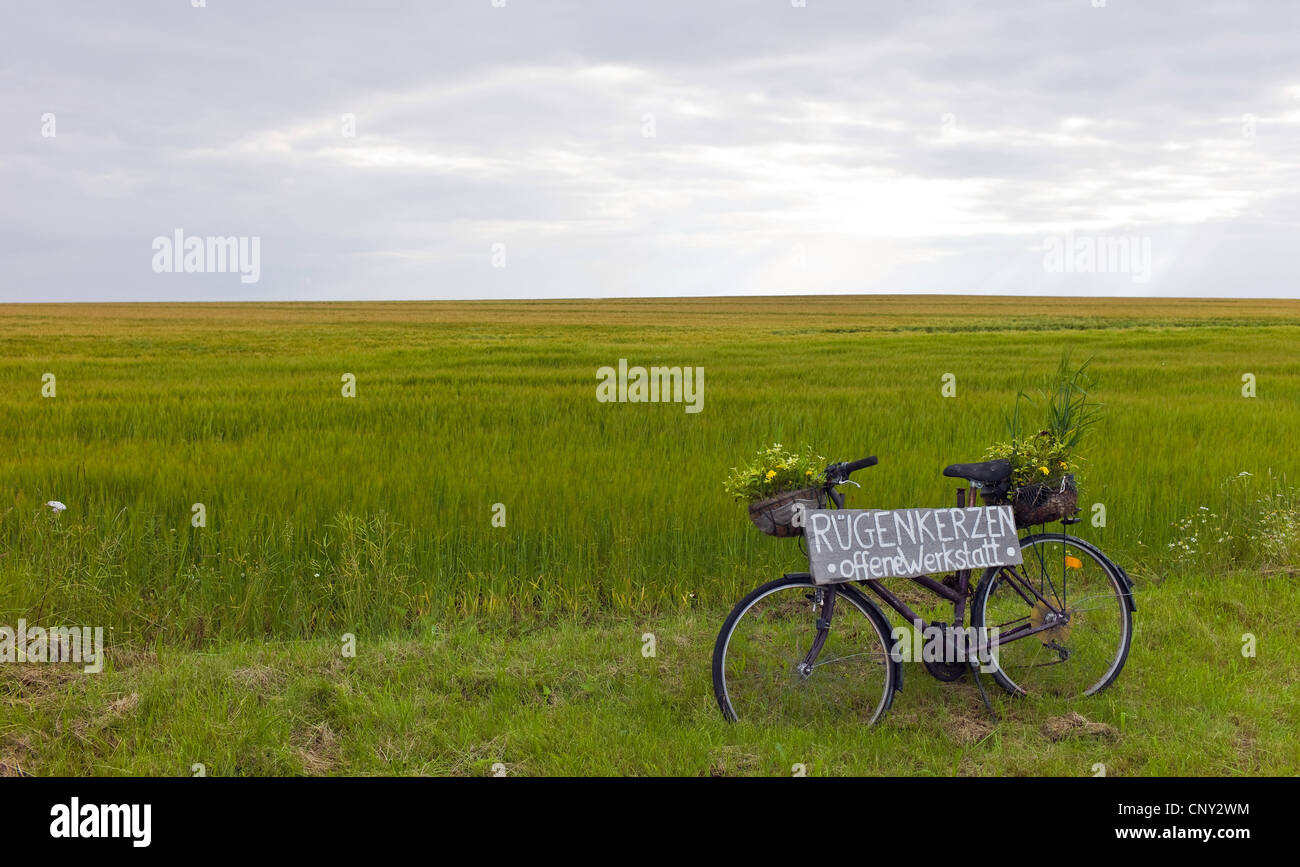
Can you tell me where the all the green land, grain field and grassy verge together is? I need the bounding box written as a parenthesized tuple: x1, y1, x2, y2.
(0, 296, 1300, 775)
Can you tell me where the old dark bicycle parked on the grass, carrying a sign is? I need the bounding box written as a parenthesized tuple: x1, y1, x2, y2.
(712, 456, 1136, 724)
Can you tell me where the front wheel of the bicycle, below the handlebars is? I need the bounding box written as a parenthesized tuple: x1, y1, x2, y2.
(714, 575, 896, 725)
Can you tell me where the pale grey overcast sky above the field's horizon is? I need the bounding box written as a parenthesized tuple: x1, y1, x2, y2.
(0, 0, 1300, 302)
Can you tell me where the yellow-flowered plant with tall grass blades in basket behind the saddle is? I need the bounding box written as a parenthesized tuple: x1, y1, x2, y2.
(984, 350, 1101, 487)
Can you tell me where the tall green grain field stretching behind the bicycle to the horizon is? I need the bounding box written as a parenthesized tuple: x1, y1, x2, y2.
(0, 298, 1300, 646)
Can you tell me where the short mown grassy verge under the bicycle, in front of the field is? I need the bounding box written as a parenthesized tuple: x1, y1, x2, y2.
(0, 573, 1300, 776)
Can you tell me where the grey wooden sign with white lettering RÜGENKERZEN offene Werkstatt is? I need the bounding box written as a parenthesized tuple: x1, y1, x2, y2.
(803, 506, 1021, 584)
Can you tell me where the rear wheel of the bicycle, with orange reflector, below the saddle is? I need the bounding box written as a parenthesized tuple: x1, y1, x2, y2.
(971, 533, 1134, 698)
